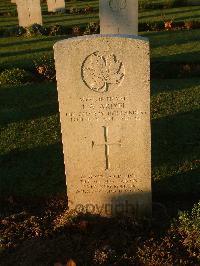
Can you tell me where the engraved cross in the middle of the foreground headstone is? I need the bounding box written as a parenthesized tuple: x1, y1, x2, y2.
(92, 126, 122, 170)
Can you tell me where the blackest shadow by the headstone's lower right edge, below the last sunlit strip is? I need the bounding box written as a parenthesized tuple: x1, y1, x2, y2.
(152, 168, 200, 218)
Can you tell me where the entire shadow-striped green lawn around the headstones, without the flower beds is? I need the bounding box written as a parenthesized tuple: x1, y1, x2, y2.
(0, 0, 200, 208)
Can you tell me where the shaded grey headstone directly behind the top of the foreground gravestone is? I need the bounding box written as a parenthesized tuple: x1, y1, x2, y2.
(99, 0, 138, 35)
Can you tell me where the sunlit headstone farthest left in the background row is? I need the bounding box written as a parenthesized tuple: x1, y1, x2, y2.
(16, 0, 42, 27)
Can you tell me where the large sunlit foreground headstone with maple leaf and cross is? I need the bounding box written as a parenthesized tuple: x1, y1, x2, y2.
(54, 35, 151, 216)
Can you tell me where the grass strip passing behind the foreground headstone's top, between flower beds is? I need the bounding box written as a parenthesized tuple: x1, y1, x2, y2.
(0, 30, 200, 69)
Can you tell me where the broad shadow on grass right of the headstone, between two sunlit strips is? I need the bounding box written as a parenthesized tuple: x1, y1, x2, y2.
(152, 110, 200, 167)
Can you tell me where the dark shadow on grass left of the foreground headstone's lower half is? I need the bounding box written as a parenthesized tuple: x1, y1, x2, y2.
(0, 143, 66, 196)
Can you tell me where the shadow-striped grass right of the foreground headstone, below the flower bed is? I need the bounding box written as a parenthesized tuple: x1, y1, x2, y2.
(151, 79, 200, 195)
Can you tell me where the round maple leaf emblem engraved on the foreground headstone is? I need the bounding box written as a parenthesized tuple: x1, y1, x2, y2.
(82, 52, 124, 92)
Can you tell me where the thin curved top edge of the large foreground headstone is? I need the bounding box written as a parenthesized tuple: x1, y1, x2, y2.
(53, 34, 149, 49)
